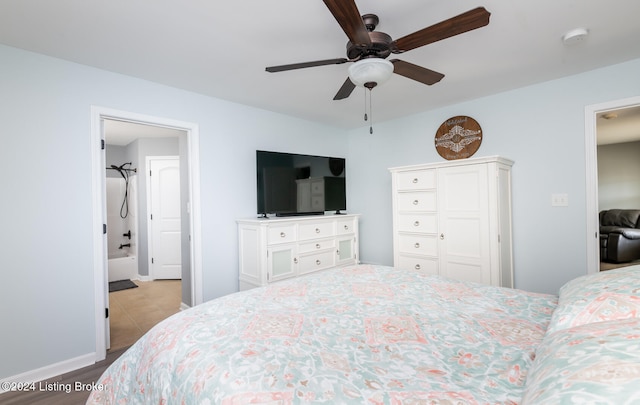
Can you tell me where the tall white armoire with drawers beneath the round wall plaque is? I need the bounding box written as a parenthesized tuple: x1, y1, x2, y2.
(389, 156, 513, 287)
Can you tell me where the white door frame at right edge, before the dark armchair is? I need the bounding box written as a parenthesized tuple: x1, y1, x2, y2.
(584, 97, 640, 274)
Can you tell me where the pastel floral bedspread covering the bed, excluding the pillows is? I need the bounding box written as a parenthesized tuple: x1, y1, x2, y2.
(87, 265, 557, 404)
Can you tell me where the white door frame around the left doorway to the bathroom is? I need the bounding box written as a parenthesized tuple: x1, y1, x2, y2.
(91, 105, 203, 361)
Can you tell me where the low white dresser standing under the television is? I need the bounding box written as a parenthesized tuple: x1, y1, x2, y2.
(236, 214, 359, 290)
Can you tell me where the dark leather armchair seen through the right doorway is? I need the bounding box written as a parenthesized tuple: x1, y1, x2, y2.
(600, 209, 640, 263)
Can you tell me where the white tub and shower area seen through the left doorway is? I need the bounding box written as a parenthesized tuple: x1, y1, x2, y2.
(106, 163, 139, 282)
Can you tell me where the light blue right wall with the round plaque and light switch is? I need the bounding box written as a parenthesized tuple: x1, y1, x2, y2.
(347, 56, 640, 293)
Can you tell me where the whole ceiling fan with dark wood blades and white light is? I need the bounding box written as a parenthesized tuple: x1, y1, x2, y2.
(266, 0, 491, 100)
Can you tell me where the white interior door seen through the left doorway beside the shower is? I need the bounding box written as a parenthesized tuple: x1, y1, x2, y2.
(147, 156, 182, 280)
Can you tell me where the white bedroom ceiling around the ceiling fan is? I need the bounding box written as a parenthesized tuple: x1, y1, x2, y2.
(0, 0, 640, 134)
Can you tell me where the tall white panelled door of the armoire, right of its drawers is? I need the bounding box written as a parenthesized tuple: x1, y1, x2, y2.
(438, 165, 491, 284)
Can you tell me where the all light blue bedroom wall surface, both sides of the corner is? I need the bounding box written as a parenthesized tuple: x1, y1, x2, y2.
(0, 39, 640, 378)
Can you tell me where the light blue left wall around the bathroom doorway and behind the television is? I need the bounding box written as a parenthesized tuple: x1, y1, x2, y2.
(0, 46, 347, 378)
